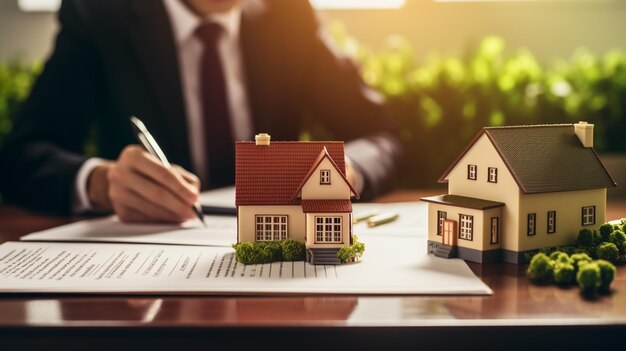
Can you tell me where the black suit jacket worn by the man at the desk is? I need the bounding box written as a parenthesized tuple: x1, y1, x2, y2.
(0, 0, 399, 213)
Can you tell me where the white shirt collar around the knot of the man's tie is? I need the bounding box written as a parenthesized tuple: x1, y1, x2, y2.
(163, 0, 241, 44)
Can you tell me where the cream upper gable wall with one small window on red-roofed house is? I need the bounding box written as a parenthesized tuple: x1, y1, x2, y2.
(302, 158, 351, 200)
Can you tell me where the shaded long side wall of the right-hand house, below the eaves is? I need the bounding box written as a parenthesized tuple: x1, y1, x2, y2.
(517, 189, 606, 251)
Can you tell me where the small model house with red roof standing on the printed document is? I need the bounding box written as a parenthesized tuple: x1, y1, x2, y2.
(235, 133, 359, 264)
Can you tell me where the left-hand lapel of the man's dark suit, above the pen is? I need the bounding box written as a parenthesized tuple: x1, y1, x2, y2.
(130, 0, 191, 169)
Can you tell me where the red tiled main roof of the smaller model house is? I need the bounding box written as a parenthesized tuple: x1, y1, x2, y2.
(235, 141, 346, 206)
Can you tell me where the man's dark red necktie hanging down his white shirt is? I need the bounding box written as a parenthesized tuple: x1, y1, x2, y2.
(196, 23, 235, 188)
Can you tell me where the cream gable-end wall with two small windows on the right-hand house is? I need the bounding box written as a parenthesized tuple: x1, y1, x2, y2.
(448, 134, 520, 251)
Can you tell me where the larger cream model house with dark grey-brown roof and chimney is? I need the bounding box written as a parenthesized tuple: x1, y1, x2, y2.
(421, 122, 616, 263)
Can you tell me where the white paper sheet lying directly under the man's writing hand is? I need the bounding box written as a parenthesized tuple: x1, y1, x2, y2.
(20, 216, 237, 246)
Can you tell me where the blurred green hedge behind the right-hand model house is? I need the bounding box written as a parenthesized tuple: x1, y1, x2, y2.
(331, 25, 626, 186)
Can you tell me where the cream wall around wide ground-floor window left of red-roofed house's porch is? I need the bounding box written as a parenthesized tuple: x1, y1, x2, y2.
(237, 205, 306, 243)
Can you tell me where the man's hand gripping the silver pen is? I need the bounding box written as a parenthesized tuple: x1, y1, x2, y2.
(87, 145, 200, 223)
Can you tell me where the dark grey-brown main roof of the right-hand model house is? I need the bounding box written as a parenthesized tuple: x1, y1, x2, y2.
(439, 124, 616, 194)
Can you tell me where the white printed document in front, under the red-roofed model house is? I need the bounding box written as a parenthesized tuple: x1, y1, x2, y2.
(0, 236, 492, 295)
